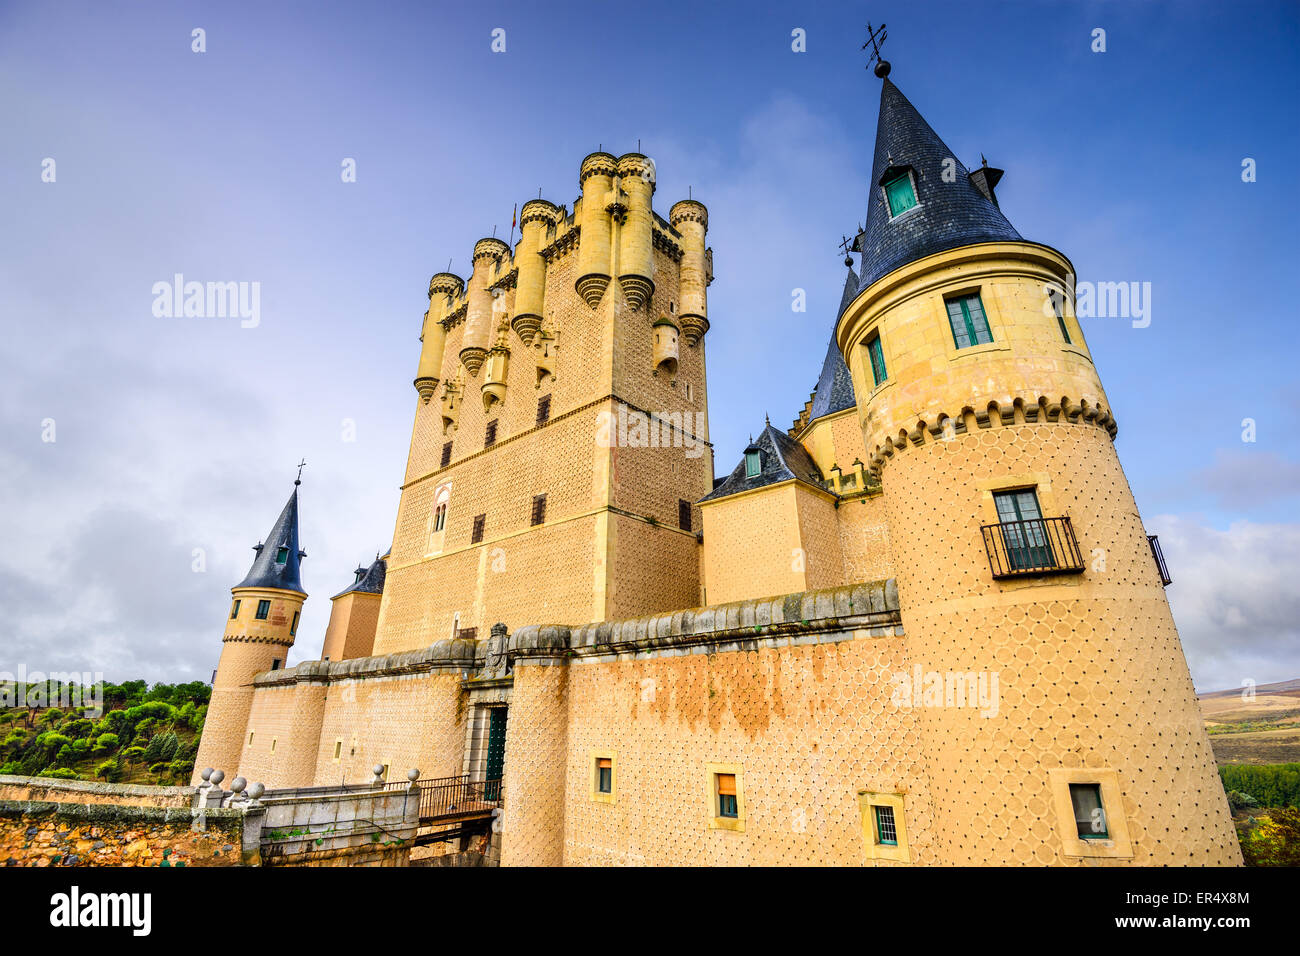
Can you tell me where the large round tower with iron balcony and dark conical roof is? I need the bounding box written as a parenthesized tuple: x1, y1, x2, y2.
(836, 74, 1240, 865)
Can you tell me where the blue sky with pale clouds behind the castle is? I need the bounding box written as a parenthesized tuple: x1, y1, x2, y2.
(0, 0, 1300, 691)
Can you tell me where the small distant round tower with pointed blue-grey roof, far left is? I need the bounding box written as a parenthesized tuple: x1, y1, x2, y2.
(191, 481, 307, 784)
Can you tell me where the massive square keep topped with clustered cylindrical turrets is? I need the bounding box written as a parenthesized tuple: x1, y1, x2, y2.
(373, 152, 712, 654)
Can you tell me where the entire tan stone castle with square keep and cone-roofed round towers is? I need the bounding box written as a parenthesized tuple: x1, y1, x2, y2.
(195, 64, 1240, 865)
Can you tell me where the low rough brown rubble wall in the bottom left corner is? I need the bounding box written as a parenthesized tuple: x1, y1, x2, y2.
(0, 800, 244, 866)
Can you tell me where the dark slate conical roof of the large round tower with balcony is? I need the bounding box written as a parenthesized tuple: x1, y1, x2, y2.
(858, 77, 1021, 289)
